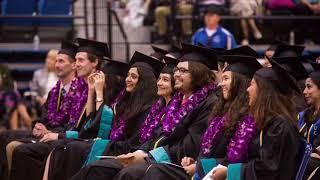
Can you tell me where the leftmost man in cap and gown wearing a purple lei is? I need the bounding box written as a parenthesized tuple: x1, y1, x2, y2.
(0, 41, 87, 179)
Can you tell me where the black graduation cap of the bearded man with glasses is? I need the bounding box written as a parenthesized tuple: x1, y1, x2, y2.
(179, 43, 218, 70)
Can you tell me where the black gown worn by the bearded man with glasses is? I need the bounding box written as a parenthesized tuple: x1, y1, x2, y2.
(72, 92, 217, 180)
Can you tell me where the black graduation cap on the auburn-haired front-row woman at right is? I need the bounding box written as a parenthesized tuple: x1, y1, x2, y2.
(255, 59, 301, 95)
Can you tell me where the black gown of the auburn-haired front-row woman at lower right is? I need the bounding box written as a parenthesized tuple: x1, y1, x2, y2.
(235, 117, 301, 180)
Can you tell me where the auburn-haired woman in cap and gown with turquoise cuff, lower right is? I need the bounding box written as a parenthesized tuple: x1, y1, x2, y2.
(212, 61, 301, 180)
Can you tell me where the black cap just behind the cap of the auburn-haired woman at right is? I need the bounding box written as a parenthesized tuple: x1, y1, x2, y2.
(272, 57, 309, 81)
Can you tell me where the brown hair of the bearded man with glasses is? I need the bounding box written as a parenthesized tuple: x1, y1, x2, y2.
(188, 61, 215, 91)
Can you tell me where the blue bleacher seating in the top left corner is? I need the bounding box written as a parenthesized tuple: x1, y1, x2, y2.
(0, 0, 74, 42)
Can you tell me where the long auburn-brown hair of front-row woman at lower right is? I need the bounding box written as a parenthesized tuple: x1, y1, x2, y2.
(250, 75, 297, 130)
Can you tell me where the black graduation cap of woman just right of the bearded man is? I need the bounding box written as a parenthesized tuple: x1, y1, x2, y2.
(222, 55, 262, 78)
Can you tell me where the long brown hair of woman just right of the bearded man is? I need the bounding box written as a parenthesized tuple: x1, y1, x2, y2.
(211, 72, 251, 135)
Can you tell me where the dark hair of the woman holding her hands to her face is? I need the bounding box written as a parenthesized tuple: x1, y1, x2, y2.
(103, 74, 125, 106)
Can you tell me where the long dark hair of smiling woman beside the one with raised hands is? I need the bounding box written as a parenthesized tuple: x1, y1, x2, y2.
(115, 66, 157, 134)
